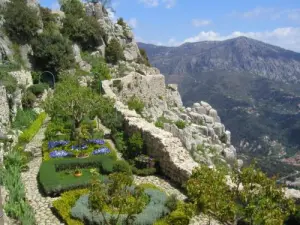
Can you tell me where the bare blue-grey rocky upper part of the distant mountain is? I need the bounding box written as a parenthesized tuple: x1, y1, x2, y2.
(138, 37, 300, 83)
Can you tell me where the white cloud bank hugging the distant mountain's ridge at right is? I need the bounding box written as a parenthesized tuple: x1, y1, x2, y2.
(182, 27, 300, 52)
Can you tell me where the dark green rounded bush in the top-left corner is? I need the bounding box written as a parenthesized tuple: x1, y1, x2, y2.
(3, 0, 41, 44)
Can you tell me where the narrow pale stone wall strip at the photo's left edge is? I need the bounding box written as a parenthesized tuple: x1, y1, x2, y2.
(0, 85, 9, 134)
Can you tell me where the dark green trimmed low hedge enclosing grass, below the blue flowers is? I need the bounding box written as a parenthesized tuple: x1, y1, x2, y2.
(38, 155, 119, 196)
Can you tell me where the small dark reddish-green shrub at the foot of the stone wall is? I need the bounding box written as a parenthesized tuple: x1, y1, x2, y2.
(126, 132, 144, 158)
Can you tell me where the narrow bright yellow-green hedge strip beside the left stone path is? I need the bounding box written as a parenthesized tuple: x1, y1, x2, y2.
(19, 112, 47, 144)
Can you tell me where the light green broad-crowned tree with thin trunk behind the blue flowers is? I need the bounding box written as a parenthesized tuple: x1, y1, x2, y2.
(44, 76, 102, 139)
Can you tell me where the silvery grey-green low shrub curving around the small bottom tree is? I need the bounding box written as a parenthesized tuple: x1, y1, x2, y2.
(71, 189, 169, 225)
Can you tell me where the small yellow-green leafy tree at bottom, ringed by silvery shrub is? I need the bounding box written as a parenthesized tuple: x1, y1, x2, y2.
(89, 173, 145, 225)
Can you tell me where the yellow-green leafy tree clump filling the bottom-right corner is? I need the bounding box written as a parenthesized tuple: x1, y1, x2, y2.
(187, 165, 294, 225)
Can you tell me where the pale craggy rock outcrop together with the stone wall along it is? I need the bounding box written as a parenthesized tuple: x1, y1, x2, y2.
(102, 67, 236, 182)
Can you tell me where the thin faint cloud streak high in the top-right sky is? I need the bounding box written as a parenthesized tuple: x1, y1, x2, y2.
(230, 7, 300, 21)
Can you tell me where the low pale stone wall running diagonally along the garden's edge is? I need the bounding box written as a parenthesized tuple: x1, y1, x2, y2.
(102, 80, 198, 183)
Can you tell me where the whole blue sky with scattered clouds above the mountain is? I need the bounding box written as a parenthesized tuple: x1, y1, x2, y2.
(40, 0, 300, 52)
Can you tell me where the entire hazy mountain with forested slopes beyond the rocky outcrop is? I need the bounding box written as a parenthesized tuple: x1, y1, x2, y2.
(138, 37, 300, 165)
